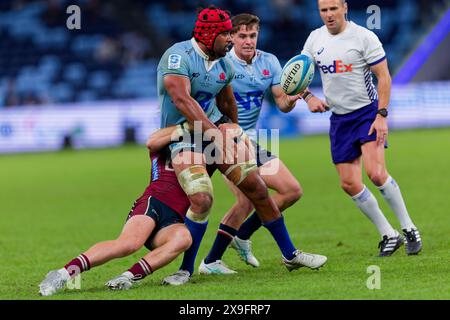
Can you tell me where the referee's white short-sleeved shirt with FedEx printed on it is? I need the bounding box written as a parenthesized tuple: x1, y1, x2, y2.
(302, 21, 386, 114)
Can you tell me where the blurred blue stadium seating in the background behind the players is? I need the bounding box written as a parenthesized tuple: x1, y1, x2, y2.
(0, 0, 442, 107)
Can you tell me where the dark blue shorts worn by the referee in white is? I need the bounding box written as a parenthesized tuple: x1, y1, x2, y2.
(330, 100, 387, 164)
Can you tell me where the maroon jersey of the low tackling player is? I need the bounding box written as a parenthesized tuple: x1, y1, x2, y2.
(144, 152, 190, 218)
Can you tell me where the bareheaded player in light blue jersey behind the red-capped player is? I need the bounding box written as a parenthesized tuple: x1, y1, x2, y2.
(199, 13, 302, 274)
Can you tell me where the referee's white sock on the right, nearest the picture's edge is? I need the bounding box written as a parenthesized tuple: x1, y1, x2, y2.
(377, 176, 416, 230)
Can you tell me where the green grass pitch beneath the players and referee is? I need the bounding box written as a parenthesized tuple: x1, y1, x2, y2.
(0, 129, 450, 300)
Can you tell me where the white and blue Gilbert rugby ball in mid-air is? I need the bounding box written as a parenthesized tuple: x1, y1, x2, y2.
(280, 54, 314, 96)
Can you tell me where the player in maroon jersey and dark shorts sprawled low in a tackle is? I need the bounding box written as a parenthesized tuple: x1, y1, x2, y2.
(39, 152, 196, 296)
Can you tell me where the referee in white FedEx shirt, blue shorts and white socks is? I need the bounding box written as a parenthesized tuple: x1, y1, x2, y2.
(302, 0, 422, 256)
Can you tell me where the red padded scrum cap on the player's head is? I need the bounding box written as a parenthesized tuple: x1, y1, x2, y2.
(194, 6, 233, 51)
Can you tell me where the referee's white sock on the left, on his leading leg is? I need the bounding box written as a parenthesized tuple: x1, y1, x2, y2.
(352, 186, 398, 238)
